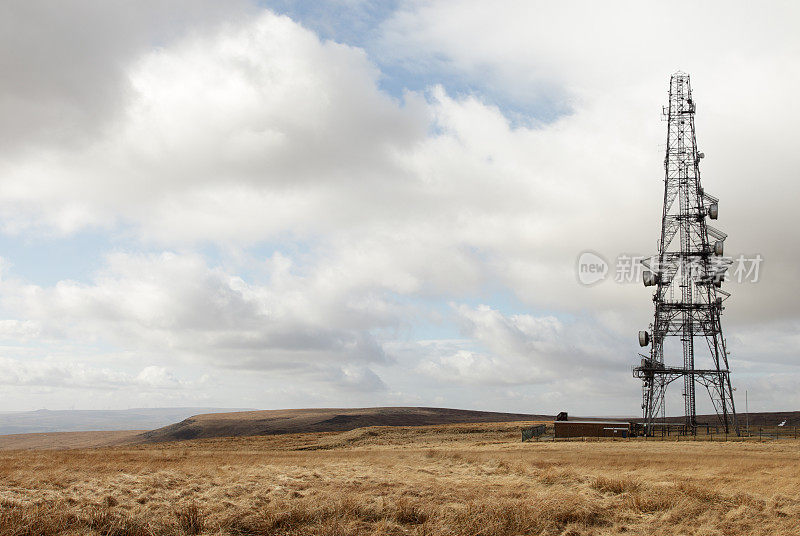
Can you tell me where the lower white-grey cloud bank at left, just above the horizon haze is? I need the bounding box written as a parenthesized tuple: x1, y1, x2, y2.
(3, 253, 392, 374)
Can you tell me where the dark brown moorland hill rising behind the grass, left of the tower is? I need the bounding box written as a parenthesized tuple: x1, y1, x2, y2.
(134, 407, 553, 443)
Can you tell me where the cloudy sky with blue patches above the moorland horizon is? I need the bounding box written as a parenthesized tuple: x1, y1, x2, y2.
(0, 0, 800, 416)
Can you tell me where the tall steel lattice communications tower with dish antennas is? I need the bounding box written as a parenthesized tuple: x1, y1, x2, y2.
(634, 72, 738, 433)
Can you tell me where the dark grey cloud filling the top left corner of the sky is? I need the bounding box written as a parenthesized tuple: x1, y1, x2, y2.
(0, 0, 253, 153)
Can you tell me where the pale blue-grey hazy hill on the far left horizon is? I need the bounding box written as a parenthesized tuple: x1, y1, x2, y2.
(0, 407, 250, 435)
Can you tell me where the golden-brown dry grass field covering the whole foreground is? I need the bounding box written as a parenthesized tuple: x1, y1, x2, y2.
(0, 423, 800, 536)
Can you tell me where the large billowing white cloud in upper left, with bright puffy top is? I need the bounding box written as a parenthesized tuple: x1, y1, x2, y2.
(0, 12, 427, 239)
